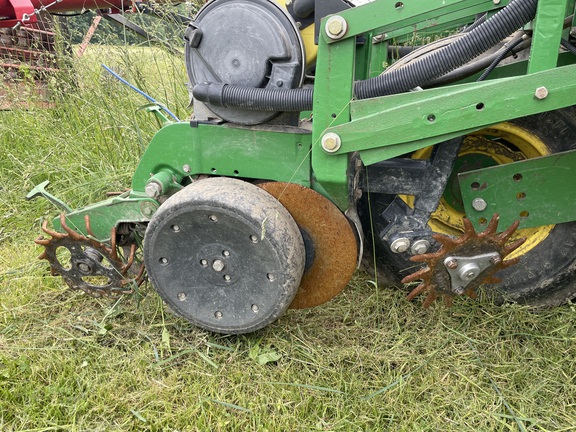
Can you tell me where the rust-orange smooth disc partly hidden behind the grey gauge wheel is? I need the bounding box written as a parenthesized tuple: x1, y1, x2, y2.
(259, 182, 358, 309)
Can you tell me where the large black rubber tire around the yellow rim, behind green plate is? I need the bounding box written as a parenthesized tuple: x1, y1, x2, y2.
(362, 106, 576, 307)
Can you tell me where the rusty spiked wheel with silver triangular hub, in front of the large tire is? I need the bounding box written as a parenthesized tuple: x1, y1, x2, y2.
(402, 214, 526, 308)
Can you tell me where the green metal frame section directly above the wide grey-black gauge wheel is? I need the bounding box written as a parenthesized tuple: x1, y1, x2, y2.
(132, 122, 311, 192)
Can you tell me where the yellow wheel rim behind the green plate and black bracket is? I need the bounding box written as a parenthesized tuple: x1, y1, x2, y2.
(400, 123, 554, 258)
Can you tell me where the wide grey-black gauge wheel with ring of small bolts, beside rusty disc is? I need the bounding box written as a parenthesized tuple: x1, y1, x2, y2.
(144, 177, 305, 334)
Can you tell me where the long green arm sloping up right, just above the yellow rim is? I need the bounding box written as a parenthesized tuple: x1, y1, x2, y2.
(327, 65, 576, 165)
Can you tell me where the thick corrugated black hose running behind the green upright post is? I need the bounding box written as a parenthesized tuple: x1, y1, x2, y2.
(193, 0, 538, 112)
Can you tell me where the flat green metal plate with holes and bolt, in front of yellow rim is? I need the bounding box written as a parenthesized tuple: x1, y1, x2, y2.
(458, 150, 576, 230)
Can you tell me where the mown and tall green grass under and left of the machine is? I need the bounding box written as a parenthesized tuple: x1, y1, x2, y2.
(0, 47, 576, 431)
